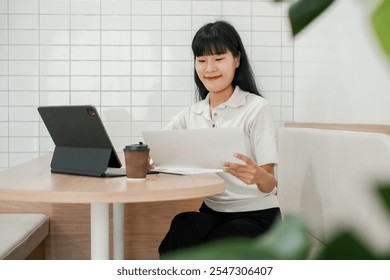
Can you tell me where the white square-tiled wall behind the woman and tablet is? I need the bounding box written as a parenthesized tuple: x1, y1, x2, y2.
(0, 0, 294, 169)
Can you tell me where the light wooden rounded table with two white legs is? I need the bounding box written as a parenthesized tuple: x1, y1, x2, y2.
(0, 154, 224, 259)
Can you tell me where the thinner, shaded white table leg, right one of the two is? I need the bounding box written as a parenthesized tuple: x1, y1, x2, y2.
(112, 203, 125, 260)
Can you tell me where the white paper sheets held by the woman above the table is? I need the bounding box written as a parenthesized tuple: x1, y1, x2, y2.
(142, 128, 246, 174)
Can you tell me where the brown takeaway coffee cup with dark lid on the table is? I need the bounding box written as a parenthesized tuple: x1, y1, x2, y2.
(123, 142, 150, 180)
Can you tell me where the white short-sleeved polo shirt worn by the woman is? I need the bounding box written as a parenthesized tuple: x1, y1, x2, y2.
(165, 86, 279, 212)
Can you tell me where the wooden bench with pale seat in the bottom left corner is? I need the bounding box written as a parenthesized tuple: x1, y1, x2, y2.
(0, 214, 49, 260)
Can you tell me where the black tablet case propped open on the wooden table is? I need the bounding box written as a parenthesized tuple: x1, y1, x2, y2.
(38, 105, 121, 177)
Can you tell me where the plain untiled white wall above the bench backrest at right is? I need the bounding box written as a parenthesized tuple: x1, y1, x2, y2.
(294, 0, 390, 124)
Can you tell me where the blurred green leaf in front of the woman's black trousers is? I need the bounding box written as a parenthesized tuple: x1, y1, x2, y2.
(161, 215, 310, 260)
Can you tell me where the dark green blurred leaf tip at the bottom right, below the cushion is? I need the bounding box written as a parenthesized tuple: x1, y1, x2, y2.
(316, 231, 378, 260)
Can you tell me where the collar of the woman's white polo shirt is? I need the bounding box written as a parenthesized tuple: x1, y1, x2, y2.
(192, 86, 250, 114)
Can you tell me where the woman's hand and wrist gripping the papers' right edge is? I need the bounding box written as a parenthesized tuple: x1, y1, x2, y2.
(222, 154, 276, 191)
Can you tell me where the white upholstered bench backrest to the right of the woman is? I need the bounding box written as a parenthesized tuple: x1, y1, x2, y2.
(278, 127, 390, 254)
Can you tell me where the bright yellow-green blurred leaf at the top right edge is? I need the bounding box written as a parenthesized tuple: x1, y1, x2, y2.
(371, 0, 390, 58)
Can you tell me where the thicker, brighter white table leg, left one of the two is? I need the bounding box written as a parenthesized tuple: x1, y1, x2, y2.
(91, 203, 110, 260)
